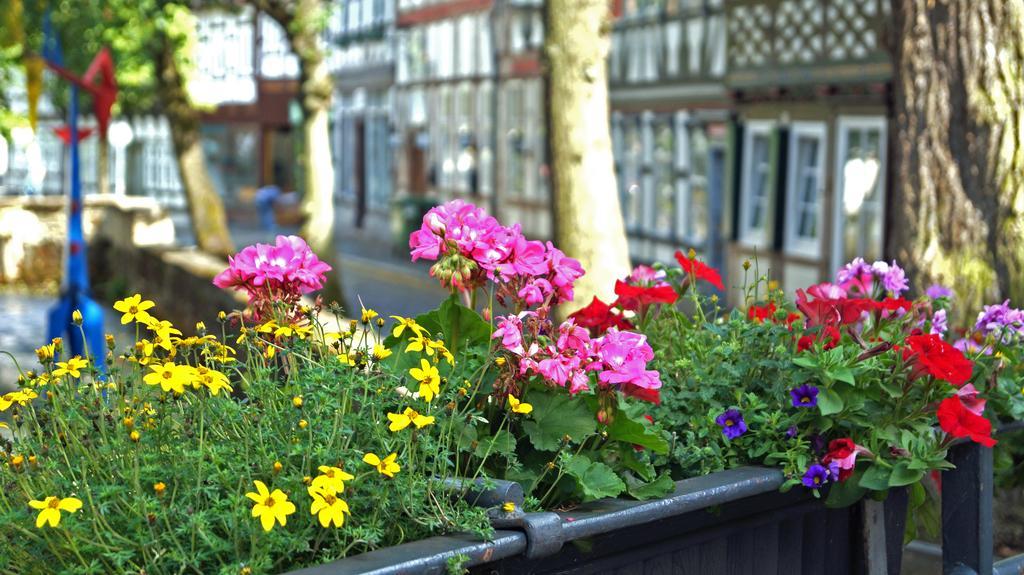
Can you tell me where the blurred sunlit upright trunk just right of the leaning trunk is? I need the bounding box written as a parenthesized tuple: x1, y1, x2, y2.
(255, 0, 347, 310)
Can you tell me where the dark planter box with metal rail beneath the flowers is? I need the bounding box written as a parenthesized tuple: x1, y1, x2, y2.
(291, 468, 906, 575)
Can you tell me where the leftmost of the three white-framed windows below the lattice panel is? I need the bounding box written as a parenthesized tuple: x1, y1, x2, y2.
(739, 122, 773, 246)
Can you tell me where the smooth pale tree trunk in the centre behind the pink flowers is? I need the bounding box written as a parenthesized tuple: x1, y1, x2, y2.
(545, 0, 630, 313)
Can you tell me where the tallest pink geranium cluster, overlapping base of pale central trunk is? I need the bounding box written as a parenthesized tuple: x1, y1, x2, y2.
(409, 200, 584, 307)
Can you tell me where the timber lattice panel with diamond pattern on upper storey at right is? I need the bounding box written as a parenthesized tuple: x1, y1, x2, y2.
(727, 0, 891, 87)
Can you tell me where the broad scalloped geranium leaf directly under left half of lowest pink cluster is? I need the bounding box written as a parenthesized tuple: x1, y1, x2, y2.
(522, 388, 597, 451)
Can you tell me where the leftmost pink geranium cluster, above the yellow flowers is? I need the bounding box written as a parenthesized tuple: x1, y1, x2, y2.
(213, 235, 331, 305)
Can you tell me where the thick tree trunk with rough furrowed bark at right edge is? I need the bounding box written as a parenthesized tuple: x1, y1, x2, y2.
(889, 0, 1024, 313)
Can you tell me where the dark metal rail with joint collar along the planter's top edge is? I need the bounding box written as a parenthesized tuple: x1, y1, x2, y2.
(287, 467, 783, 575)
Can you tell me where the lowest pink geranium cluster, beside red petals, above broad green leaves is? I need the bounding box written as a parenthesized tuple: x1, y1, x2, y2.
(492, 312, 662, 403)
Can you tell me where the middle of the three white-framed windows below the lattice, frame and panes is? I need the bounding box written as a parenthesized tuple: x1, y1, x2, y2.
(785, 122, 825, 258)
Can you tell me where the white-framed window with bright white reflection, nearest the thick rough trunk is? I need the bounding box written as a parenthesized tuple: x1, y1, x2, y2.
(833, 117, 886, 267)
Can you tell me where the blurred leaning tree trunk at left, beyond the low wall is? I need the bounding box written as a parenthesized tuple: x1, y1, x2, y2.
(157, 39, 234, 257)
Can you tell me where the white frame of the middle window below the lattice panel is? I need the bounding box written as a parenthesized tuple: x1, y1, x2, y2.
(784, 122, 828, 259)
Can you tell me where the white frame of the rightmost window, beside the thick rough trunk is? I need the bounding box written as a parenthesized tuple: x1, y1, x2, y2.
(831, 116, 889, 269)
